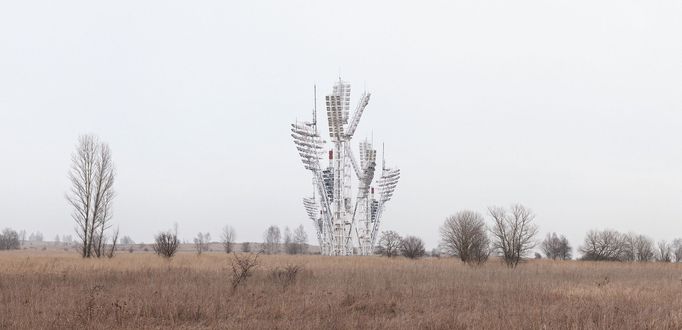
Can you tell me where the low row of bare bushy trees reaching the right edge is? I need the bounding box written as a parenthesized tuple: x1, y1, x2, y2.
(579, 230, 682, 262)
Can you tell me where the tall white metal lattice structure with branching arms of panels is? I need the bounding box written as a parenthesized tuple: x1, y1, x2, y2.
(291, 79, 400, 255)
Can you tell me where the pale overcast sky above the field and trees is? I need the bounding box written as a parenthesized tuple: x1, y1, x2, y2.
(0, 0, 682, 248)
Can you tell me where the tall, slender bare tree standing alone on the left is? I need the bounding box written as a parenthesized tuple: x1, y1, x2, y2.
(66, 135, 115, 258)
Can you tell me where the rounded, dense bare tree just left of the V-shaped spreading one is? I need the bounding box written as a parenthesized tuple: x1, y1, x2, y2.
(440, 210, 490, 264)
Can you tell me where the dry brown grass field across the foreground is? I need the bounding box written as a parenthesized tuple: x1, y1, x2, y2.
(0, 251, 682, 329)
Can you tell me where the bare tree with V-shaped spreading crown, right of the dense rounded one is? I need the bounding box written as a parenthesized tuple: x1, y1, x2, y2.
(488, 204, 538, 268)
